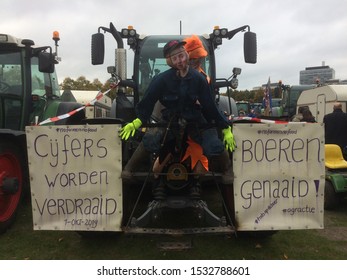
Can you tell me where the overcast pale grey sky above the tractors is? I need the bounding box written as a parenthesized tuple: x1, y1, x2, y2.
(0, 0, 347, 90)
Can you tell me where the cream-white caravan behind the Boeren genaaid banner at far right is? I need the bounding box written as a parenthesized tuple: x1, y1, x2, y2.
(296, 85, 347, 122)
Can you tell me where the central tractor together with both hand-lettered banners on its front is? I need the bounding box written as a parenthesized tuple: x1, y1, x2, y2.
(26, 23, 324, 236)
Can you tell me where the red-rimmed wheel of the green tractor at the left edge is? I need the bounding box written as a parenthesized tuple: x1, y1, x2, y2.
(0, 140, 25, 233)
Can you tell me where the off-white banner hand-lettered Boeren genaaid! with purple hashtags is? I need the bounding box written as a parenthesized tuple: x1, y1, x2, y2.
(233, 122, 325, 231)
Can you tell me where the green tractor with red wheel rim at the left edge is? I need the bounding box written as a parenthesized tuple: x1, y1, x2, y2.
(0, 32, 84, 233)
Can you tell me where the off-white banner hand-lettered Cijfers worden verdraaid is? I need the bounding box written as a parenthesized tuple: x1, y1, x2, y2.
(26, 125, 123, 231)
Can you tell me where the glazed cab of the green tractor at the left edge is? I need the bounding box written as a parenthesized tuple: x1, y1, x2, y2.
(0, 34, 60, 130)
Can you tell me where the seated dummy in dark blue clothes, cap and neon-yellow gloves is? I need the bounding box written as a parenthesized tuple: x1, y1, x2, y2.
(120, 40, 235, 199)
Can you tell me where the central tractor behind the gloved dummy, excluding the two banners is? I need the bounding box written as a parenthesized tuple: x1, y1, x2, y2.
(88, 23, 257, 235)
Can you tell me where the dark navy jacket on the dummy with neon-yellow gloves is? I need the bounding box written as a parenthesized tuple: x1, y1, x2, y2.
(136, 68, 229, 128)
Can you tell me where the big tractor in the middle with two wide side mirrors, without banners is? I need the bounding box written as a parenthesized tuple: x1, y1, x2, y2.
(92, 23, 257, 234)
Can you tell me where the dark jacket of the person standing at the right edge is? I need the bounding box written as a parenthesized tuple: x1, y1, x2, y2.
(323, 109, 347, 149)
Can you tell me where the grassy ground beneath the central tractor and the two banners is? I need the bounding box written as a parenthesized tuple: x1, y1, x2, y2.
(0, 197, 347, 260)
